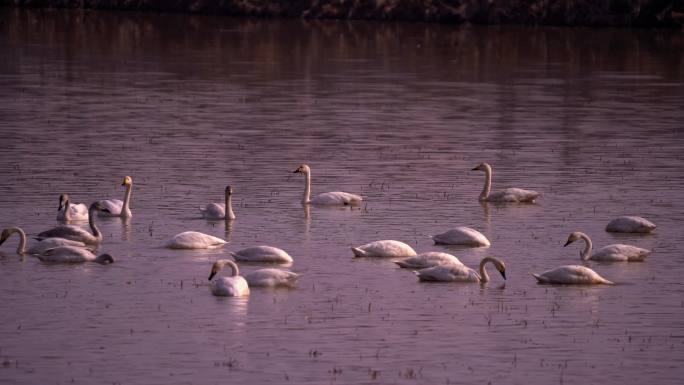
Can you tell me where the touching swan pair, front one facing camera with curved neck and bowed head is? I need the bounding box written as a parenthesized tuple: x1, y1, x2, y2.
(209, 259, 299, 297)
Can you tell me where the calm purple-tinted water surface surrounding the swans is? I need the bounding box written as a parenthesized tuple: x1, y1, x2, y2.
(0, 10, 684, 384)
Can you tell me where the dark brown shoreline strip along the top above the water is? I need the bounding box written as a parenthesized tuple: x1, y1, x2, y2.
(0, 0, 684, 28)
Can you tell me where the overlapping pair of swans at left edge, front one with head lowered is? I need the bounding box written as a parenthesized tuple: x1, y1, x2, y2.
(0, 227, 114, 264)
